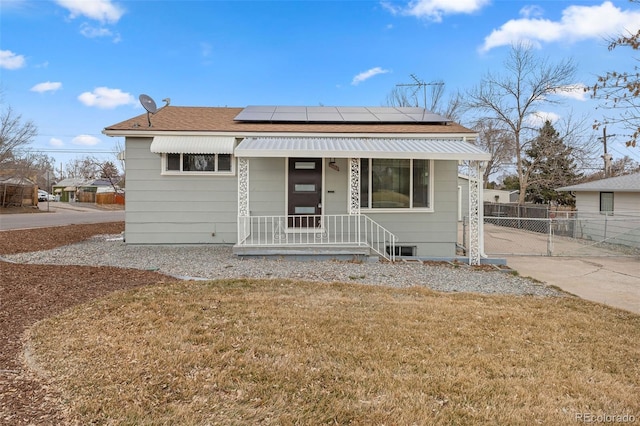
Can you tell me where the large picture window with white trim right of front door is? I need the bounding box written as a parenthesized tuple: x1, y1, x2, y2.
(360, 158, 433, 210)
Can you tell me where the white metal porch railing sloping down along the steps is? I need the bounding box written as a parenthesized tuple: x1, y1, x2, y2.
(238, 215, 397, 261)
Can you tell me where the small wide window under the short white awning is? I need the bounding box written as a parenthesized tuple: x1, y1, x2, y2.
(162, 154, 233, 174)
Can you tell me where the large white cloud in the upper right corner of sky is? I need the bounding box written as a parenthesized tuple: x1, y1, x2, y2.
(480, 1, 640, 52)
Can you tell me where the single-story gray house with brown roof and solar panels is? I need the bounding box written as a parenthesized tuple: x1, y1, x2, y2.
(103, 106, 489, 264)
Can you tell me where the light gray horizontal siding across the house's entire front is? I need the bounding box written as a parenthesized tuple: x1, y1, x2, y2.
(125, 138, 458, 257)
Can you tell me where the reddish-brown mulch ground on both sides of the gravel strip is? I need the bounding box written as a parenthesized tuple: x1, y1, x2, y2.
(0, 222, 174, 425)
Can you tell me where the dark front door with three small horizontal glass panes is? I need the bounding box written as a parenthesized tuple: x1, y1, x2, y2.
(287, 158, 322, 228)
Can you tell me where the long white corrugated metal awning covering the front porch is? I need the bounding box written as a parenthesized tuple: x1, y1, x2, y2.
(235, 137, 491, 161)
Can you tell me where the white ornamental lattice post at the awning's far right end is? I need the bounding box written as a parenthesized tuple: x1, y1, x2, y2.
(468, 161, 484, 265)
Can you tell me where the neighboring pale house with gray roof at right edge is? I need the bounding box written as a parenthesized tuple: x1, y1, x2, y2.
(557, 173, 640, 247)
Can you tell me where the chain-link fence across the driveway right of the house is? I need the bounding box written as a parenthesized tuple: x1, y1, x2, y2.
(480, 212, 640, 256)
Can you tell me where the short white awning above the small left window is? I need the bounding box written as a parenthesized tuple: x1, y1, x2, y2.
(151, 135, 236, 154)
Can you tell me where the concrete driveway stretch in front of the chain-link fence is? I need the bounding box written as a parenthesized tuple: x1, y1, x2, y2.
(506, 256, 640, 314)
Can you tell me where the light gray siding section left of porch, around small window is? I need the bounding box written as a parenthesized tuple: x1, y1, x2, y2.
(125, 138, 238, 244)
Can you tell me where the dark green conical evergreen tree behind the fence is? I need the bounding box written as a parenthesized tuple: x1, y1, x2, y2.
(524, 120, 582, 206)
